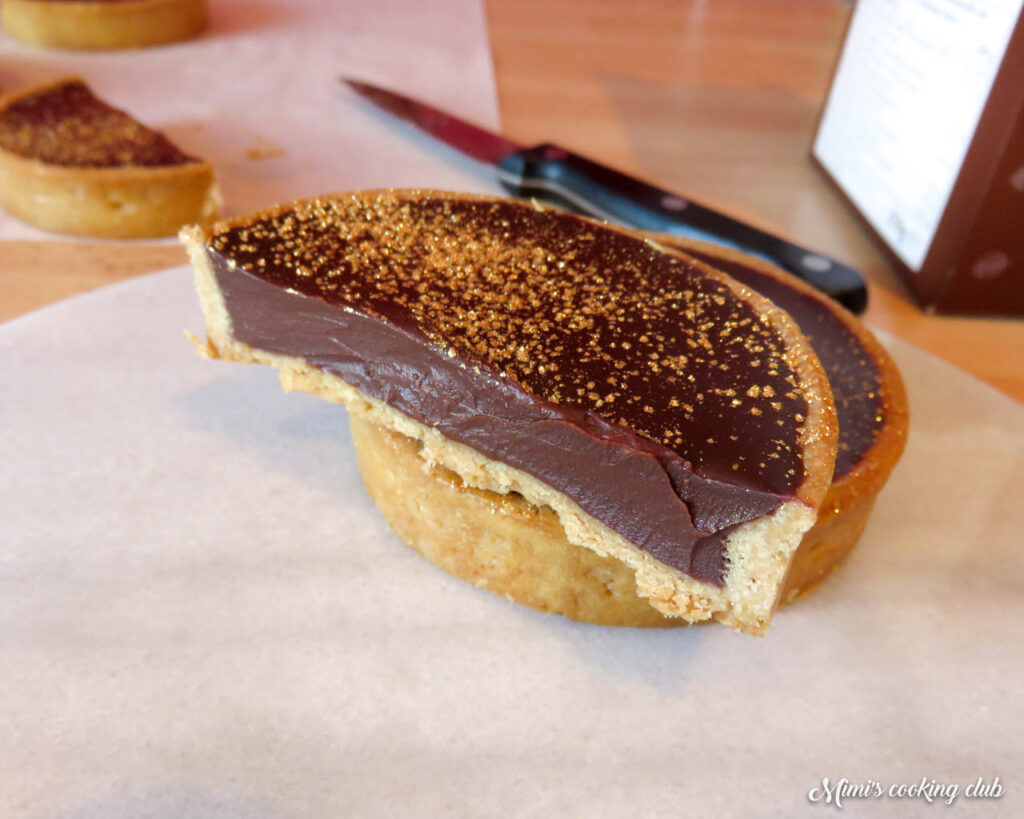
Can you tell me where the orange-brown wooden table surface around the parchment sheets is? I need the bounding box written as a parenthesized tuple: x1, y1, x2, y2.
(0, 0, 1024, 401)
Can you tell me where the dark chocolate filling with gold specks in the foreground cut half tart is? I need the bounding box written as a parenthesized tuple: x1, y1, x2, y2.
(205, 192, 808, 586)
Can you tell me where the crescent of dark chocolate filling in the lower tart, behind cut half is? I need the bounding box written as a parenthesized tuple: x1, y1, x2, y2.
(669, 243, 886, 480)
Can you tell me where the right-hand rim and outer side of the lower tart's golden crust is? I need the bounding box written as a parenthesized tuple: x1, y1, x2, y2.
(644, 233, 909, 602)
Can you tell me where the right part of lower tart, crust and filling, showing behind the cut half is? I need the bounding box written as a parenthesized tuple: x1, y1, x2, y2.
(648, 234, 909, 601)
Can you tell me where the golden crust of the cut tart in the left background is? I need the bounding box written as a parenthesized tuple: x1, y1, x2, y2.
(0, 78, 220, 239)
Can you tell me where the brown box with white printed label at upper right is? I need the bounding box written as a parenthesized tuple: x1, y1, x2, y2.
(814, 0, 1024, 315)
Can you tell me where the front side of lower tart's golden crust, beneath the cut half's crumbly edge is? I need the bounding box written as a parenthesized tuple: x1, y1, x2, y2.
(349, 414, 671, 627)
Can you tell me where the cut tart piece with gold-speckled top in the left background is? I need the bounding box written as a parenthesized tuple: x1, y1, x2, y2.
(0, 78, 220, 239)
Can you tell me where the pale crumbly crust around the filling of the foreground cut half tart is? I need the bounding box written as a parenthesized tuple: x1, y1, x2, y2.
(186, 212, 836, 635)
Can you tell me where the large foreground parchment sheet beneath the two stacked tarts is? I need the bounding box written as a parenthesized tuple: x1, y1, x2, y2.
(0, 269, 1024, 819)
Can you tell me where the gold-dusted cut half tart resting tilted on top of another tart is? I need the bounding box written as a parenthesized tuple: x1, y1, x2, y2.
(182, 191, 837, 634)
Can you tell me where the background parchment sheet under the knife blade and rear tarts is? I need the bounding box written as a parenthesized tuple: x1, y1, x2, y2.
(0, 0, 499, 239)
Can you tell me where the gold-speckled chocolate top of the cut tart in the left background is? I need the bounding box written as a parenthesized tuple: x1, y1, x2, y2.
(0, 80, 199, 168)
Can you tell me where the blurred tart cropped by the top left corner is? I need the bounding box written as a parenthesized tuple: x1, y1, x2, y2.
(0, 0, 207, 51)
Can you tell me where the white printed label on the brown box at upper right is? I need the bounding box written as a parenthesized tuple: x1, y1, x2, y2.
(814, 0, 1024, 270)
